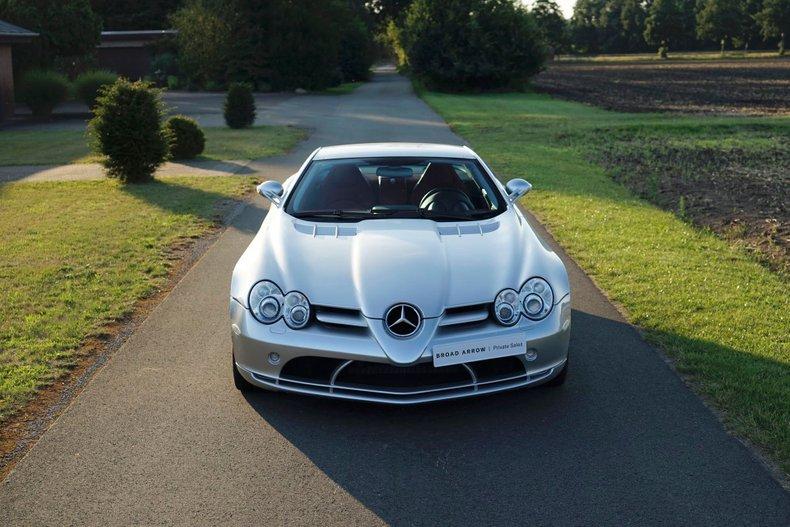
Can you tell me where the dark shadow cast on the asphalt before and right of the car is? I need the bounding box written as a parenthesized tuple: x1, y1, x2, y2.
(241, 311, 787, 525)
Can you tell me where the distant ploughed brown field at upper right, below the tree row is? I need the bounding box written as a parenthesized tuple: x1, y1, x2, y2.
(534, 57, 790, 115)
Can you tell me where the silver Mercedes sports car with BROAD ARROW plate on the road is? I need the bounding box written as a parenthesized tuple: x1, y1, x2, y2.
(230, 143, 571, 404)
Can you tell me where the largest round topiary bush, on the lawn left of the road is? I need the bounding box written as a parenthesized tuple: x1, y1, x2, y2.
(89, 78, 167, 183)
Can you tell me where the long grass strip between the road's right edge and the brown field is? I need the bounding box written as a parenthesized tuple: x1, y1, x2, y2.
(423, 89, 790, 471)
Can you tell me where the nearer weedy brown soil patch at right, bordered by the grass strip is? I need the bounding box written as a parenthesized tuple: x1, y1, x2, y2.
(595, 137, 790, 276)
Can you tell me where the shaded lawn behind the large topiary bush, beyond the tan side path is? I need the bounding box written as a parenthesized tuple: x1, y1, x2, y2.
(0, 126, 306, 166)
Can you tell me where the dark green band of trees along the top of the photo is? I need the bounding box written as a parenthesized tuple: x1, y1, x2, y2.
(0, 0, 790, 90)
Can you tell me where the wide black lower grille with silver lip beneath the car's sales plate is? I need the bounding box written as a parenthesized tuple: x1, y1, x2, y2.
(254, 357, 554, 403)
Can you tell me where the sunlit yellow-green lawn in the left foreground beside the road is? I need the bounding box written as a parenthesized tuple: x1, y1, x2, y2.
(0, 176, 252, 422)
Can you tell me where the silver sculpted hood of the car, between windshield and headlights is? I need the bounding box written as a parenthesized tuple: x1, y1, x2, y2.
(231, 207, 569, 318)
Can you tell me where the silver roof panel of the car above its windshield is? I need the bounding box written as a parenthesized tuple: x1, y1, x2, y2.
(313, 143, 475, 159)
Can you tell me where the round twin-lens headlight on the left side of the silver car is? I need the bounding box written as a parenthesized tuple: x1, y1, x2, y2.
(249, 280, 310, 329)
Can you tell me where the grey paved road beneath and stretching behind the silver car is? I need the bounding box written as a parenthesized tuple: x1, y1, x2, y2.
(0, 68, 790, 526)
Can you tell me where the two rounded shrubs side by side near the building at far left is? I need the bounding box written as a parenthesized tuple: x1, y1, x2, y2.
(19, 70, 118, 117)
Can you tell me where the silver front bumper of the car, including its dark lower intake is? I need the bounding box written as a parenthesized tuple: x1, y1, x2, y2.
(230, 296, 570, 404)
